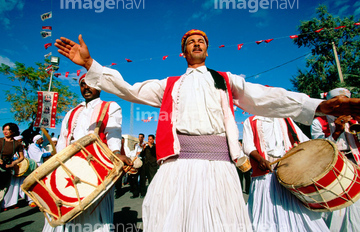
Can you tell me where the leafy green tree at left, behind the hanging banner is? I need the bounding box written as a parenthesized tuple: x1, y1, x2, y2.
(0, 60, 79, 123)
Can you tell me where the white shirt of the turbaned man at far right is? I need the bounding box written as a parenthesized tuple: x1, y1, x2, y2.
(311, 115, 350, 151)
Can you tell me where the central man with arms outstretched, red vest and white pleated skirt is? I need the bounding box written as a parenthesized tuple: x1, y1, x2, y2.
(55, 30, 360, 232)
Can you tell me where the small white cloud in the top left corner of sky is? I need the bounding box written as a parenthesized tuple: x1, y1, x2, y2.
(0, 0, 25, 29)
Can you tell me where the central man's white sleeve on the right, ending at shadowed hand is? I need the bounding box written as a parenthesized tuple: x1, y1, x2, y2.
(227, 73, 323, 125)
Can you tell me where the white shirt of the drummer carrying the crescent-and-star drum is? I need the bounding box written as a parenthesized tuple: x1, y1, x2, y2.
(56, 98, 122, 152)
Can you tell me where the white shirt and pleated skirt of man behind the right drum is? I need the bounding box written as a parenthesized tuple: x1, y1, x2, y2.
(243, 116, 328, 232)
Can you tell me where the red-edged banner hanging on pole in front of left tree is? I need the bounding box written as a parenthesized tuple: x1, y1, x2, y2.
(34, 91, 59, 129)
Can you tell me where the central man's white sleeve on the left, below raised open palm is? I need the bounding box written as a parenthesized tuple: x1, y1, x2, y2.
(85, 60, 166, 107)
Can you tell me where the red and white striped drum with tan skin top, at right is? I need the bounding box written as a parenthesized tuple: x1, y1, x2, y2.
(276, 139, 360, 212)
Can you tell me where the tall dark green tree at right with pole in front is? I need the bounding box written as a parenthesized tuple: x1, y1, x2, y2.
(291, 5, 360, 98)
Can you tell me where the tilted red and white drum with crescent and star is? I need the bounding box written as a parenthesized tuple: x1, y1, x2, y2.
(21, 134, 123, 227)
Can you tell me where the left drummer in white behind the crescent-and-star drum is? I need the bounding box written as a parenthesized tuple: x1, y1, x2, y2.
(43, 76, 131, 232)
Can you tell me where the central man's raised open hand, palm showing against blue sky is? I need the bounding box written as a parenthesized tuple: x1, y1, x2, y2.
(55, 35, 93, 70)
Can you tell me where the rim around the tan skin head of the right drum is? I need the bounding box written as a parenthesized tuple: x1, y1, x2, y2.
(275, 139, 340, 189)
